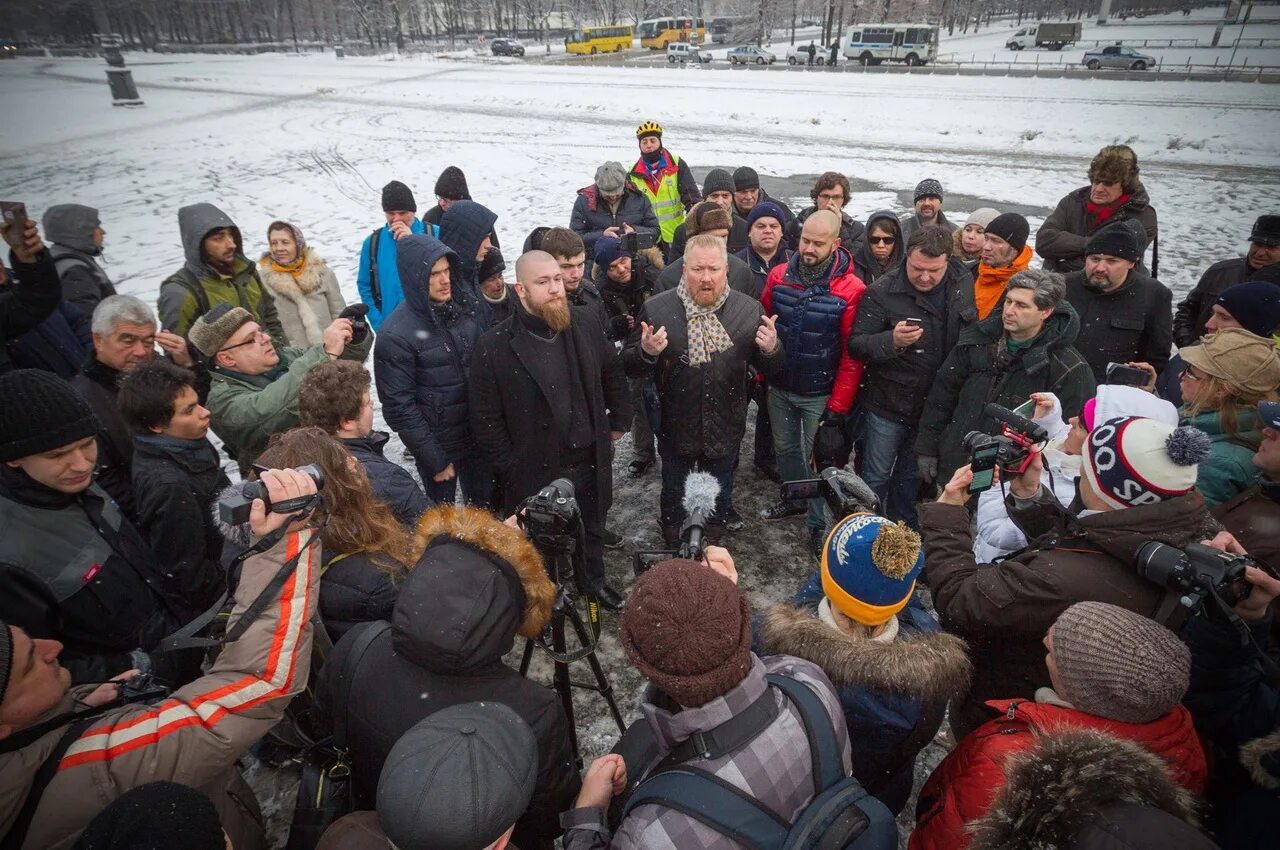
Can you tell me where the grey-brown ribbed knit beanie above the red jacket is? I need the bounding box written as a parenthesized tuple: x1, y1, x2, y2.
(1050, 602, 1192, 723)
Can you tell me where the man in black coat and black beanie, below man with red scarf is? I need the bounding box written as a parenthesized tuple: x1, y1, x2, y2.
(1066, 219, 1174, 384)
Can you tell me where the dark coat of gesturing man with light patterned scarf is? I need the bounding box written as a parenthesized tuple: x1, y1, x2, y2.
(622, 289, 786, 458)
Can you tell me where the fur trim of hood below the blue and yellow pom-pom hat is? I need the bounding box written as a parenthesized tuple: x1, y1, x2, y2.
(759, 604, 973, 702)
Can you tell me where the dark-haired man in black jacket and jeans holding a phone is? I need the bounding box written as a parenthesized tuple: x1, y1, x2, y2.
(849, 225, 978, 529)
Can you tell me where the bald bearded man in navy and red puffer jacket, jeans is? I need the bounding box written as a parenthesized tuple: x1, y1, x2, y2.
(760, 210, 867, 556)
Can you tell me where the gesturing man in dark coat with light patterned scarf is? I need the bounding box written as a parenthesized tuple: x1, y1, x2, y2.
(623, 236, 783, 544)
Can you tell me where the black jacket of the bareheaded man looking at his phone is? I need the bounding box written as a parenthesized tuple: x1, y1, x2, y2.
(849, 260, 978, 426)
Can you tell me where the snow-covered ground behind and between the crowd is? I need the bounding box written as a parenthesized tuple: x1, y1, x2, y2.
(0, 51, 1280, 844)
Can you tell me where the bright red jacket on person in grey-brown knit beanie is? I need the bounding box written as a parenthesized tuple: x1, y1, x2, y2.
(910, 699, 1207, 850)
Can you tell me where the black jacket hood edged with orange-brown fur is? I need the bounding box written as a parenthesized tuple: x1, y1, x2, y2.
(392, 506, 556, 676)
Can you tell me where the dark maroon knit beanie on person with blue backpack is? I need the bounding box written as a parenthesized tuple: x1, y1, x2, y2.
(618, 559, 751, 708)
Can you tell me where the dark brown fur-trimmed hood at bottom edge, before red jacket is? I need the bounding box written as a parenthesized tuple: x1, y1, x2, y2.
(969, 730, 1215, 850)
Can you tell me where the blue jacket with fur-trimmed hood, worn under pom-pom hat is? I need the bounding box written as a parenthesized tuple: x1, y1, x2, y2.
(753, 572, 970, 813)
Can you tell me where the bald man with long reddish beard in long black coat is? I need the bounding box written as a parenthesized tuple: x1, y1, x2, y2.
(470, 251, 631, 611)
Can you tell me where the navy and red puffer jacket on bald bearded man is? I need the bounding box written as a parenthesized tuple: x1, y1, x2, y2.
(760, 247, 867, 413)
